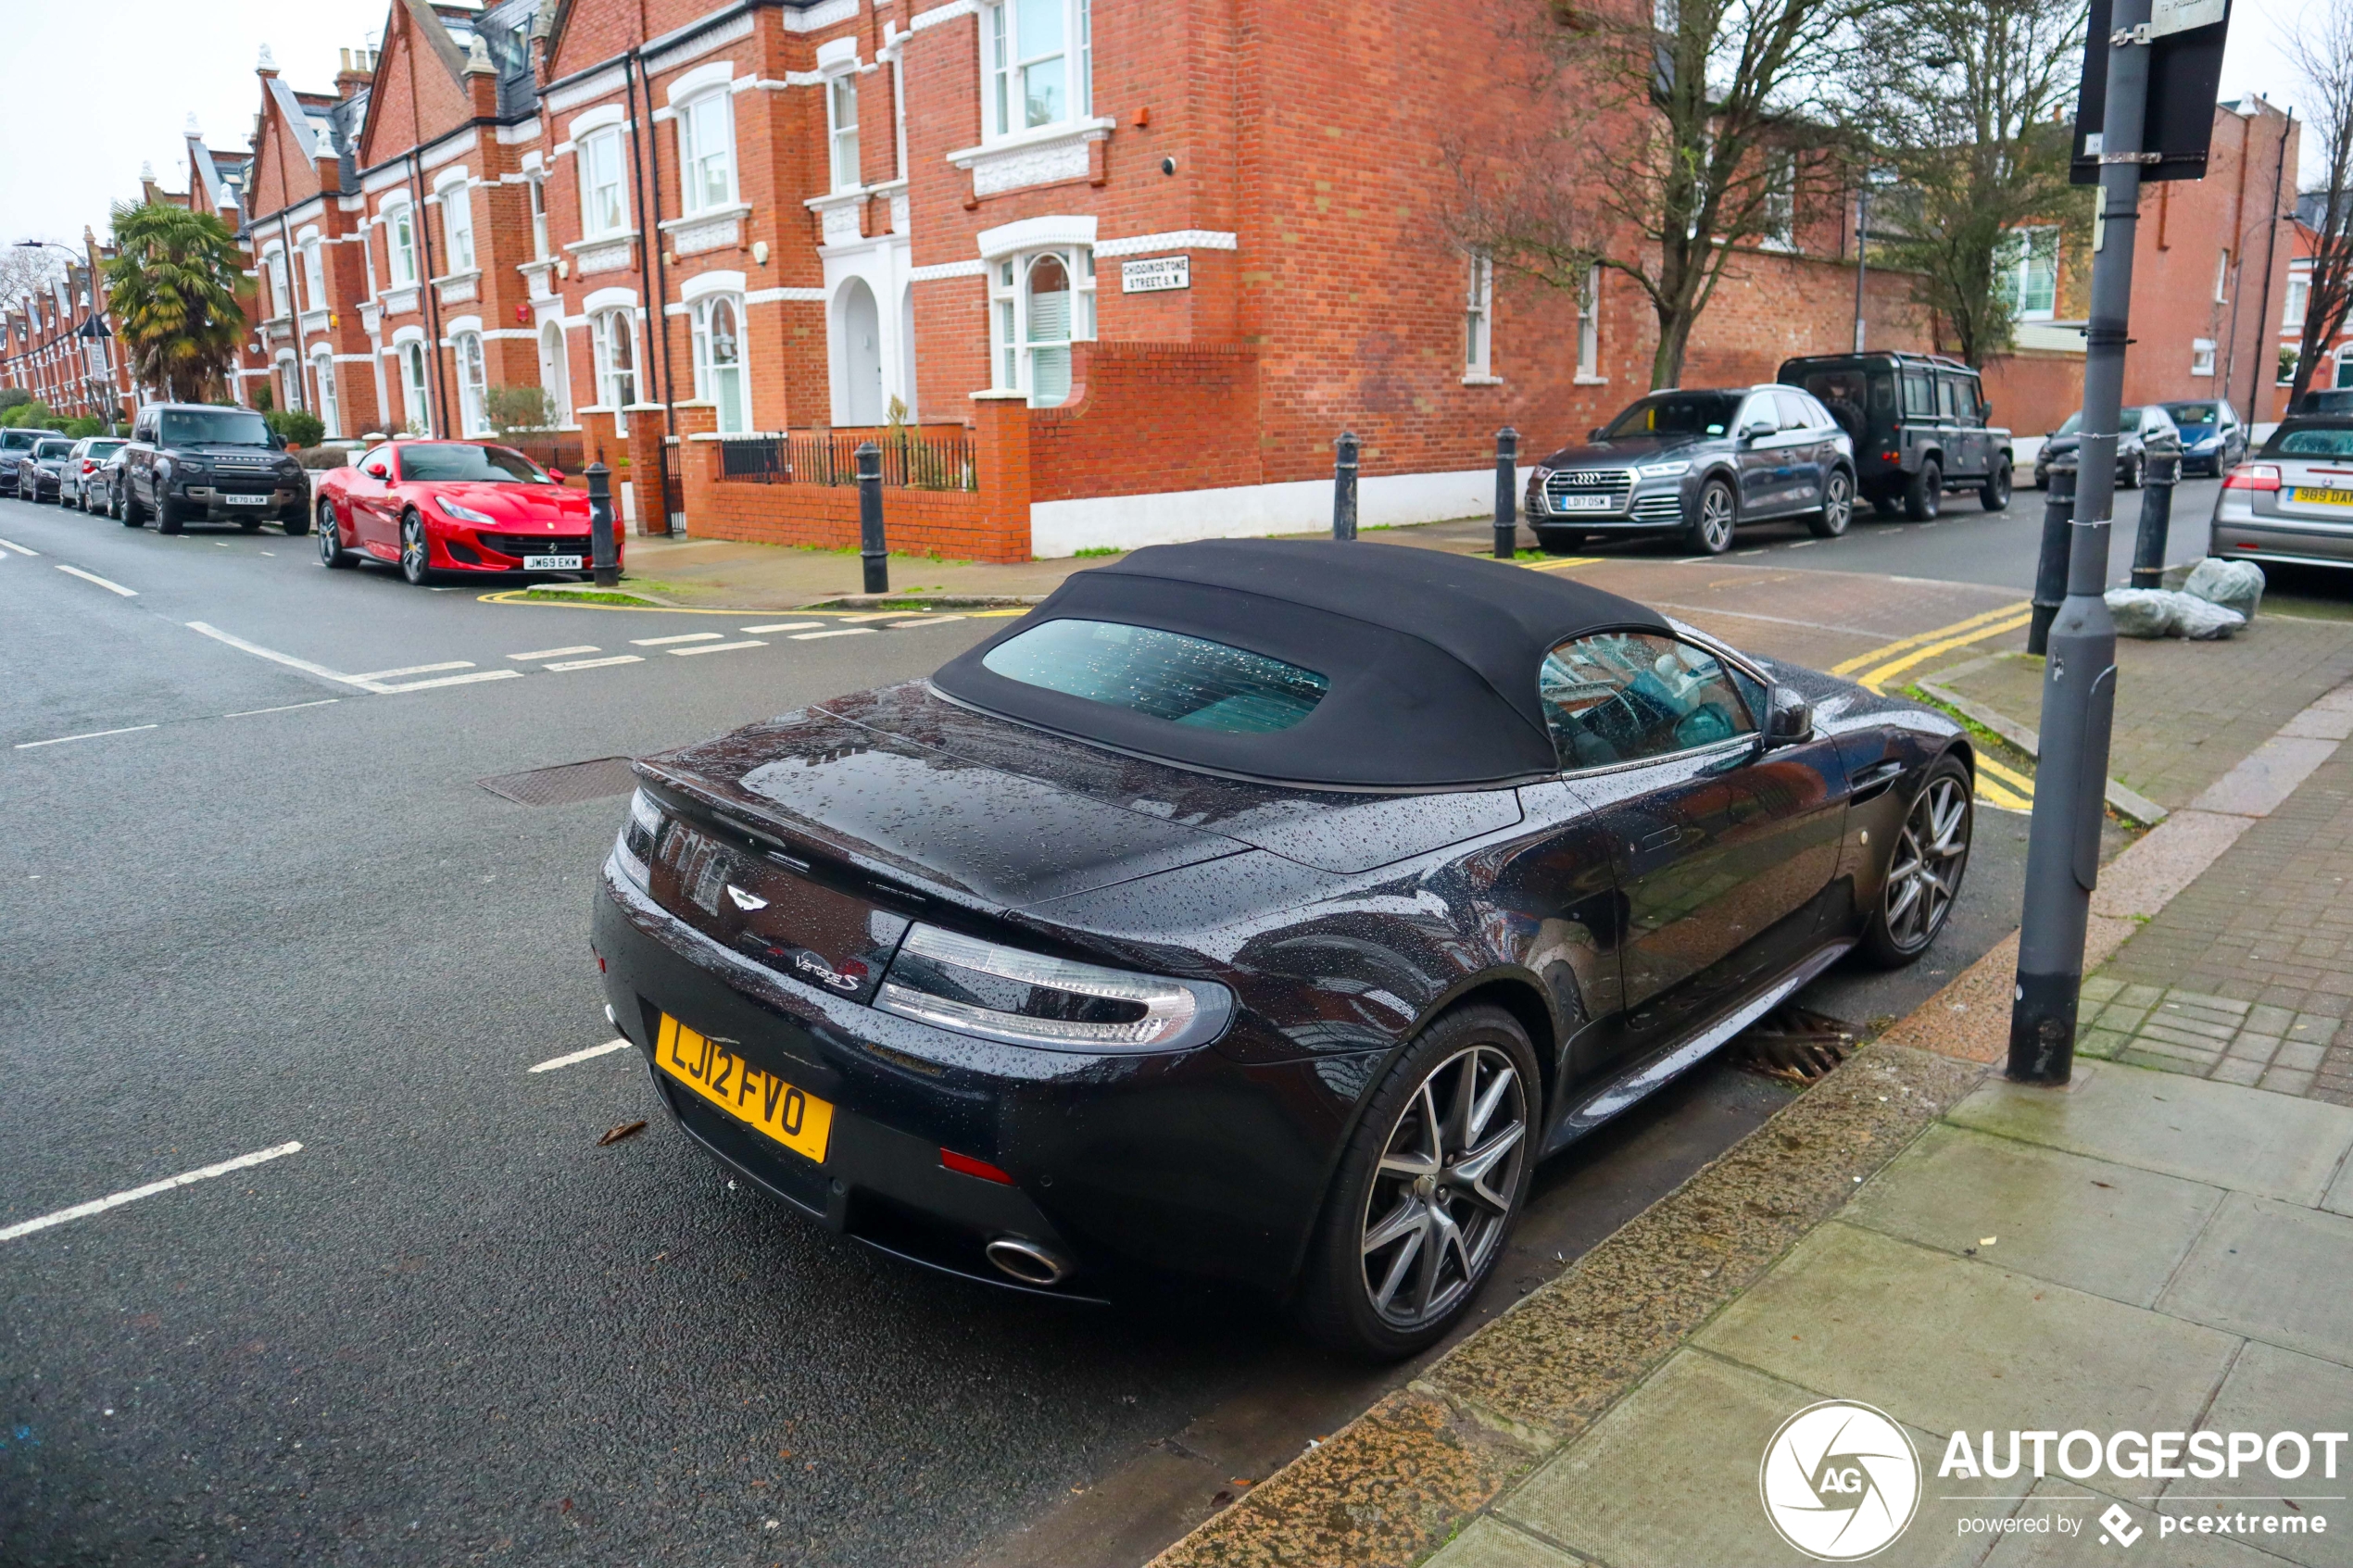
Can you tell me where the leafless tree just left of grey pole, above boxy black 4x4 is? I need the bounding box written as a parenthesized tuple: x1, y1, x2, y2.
(1849, 0, 2090, 364)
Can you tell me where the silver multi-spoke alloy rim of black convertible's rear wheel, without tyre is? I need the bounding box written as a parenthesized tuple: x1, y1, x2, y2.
(1360, 1047, 1527, 1331)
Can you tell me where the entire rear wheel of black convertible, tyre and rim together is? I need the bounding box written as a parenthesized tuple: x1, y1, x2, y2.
(1297, 1006, 1543, 1361)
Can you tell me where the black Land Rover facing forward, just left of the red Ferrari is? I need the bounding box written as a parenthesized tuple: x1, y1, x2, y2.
(118, 402, 310, 533)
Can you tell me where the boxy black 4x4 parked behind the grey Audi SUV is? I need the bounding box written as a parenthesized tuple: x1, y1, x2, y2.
(1781, 355, 2012, 521)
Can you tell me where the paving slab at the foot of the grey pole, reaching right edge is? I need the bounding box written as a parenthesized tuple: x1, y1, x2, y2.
(1946, 1062, 2353, 1204)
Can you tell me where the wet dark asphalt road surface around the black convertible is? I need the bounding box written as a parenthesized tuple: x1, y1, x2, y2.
(0, 501, 2023, 1565)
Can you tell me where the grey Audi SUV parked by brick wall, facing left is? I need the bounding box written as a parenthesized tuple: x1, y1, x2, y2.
(1525, 385, 1855, 555)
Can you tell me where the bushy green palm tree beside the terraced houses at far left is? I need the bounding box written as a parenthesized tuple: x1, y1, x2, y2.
(106, 202, 245, 397)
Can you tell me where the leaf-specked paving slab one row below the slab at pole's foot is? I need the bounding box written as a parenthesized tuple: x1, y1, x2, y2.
(1844, 1126, 2223, 1307)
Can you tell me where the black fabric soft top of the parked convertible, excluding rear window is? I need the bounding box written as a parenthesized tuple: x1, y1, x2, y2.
(932, 538, 1666, 790)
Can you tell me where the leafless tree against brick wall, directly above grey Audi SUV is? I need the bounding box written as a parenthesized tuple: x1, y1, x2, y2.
(1445, 0, 1861, 385)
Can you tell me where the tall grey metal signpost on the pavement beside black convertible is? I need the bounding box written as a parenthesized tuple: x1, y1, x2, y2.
(2009, 0, 2151, 1084)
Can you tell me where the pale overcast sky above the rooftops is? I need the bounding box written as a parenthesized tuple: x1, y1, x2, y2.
(0, 0, 2315, 260)
